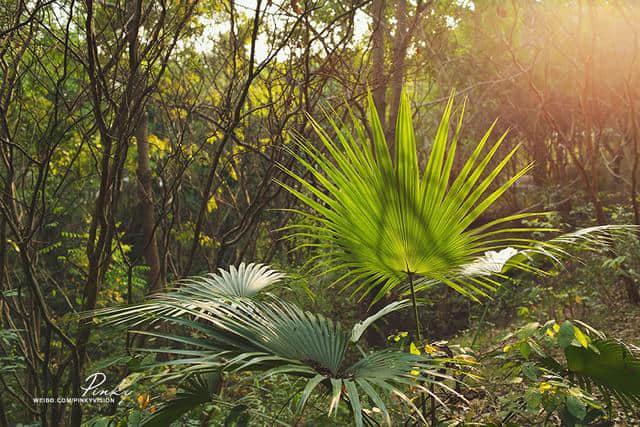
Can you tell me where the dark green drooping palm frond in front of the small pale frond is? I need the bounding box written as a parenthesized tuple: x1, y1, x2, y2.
(102, 295, 462, 426)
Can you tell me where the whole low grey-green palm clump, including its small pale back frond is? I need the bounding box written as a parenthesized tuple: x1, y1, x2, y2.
(92, 264, 464, 426)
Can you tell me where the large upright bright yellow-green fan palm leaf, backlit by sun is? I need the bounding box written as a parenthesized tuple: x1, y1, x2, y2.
(280, 90, 636, 302)
